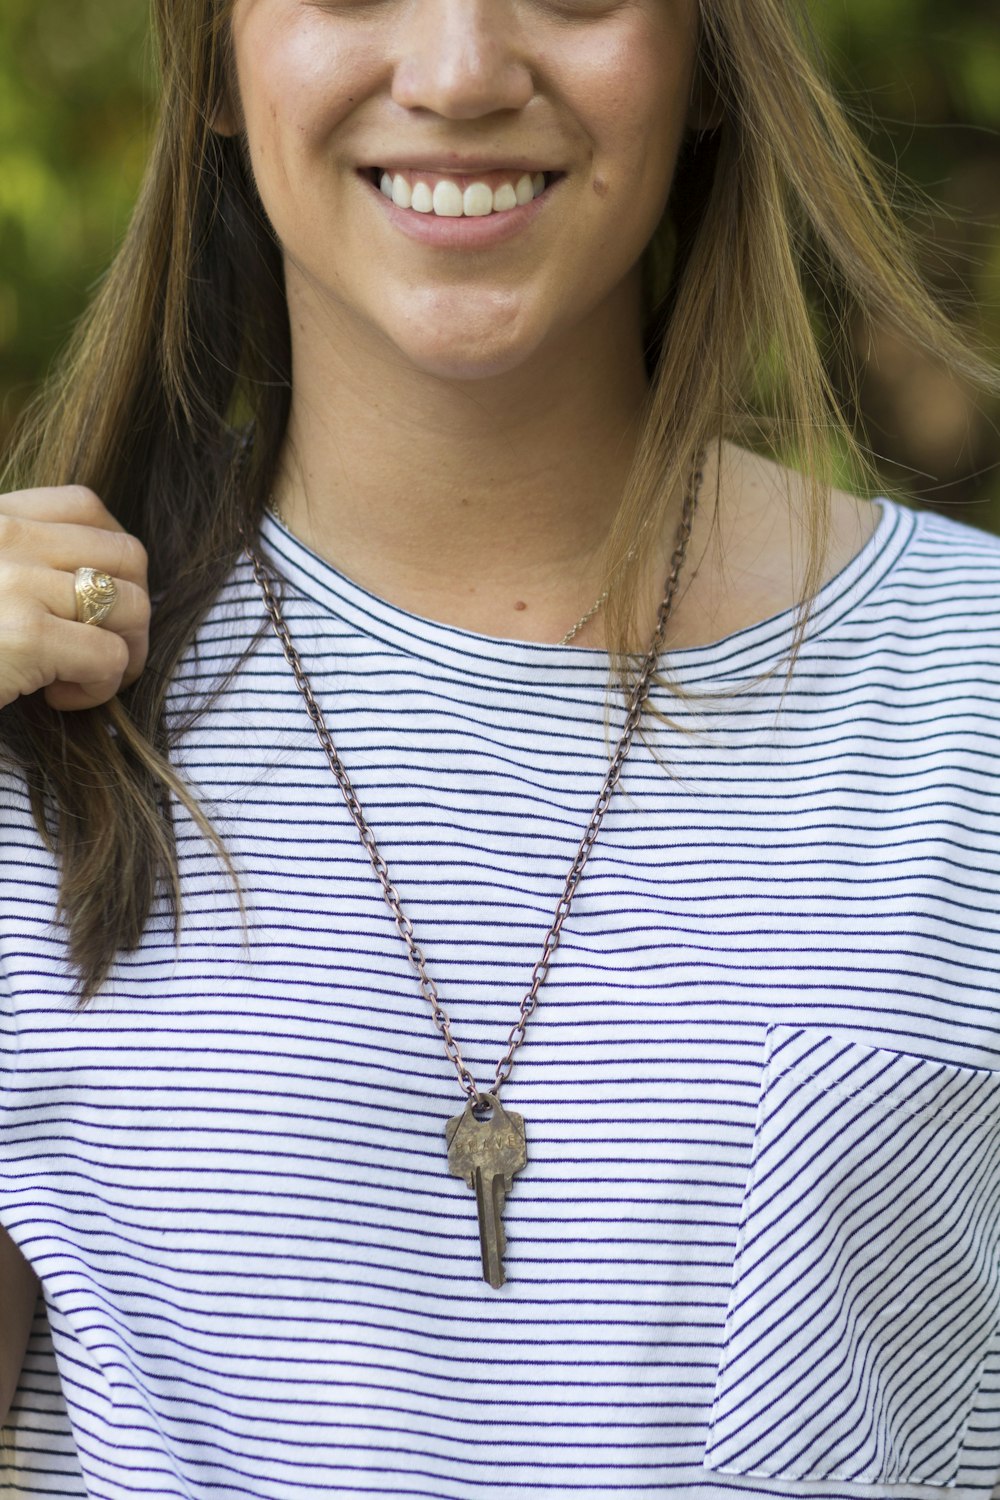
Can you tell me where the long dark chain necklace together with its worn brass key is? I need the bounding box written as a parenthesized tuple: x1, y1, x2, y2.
(244, 455, 705, 1287)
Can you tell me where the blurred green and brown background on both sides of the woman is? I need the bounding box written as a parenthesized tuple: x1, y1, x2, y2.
(0, 0, 1000, 533)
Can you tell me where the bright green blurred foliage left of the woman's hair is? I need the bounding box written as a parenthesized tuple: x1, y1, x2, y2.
(0, 0, 154, 437)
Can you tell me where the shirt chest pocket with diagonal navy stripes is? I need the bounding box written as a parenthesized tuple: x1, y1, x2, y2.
(705, 1026, 1000, 1485)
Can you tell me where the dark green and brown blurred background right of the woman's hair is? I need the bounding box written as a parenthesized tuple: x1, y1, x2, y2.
(810, 0, 1000, 533)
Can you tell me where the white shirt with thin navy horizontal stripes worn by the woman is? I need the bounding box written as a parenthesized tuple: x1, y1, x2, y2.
(0, 503, 1000, 1500)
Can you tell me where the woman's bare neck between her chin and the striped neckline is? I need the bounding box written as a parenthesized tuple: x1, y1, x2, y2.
(274, 273, 646, 644)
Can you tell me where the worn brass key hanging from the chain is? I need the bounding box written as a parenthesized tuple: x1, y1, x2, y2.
(445, 1094, 528, 1287)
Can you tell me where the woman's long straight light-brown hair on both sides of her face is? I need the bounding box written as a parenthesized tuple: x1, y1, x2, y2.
(0, 0, 997, 1005)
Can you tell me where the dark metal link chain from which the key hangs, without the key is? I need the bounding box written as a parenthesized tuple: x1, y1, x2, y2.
(244, 453, 705, 1104)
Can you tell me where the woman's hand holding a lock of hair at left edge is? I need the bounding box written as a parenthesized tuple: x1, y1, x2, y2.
(0, 485, 150, 710)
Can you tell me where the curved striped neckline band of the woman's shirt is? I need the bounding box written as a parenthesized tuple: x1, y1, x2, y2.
(259, 497, 919, 684)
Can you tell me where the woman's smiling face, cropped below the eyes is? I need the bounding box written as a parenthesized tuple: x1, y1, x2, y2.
(219, 0, 697, 378)
